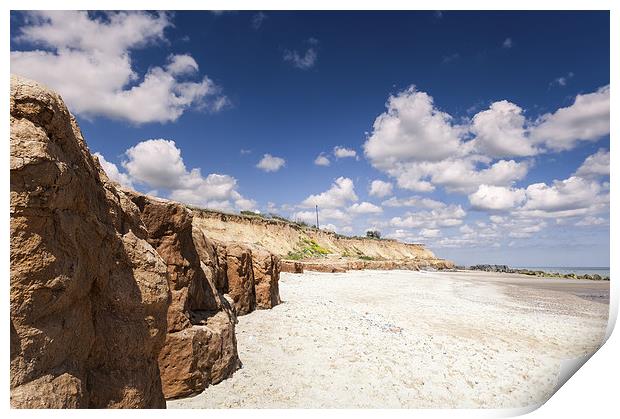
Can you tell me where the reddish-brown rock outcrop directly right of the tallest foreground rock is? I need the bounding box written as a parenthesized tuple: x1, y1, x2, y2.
(126, 191, 240, 398)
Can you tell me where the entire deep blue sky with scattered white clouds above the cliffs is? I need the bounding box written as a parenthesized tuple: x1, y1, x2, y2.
(11, 11, 609, 266)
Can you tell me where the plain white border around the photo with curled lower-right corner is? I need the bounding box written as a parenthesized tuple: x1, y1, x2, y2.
(0, 0, 620, 419)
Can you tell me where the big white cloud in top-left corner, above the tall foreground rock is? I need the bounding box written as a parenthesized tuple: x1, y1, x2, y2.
(11, 11, 228, 124)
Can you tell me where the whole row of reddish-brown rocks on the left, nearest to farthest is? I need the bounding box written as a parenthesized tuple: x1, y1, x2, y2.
(11, 78, 254, 408)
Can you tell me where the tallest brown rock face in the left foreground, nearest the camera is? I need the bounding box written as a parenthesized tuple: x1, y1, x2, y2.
(10, 77, 170, 408)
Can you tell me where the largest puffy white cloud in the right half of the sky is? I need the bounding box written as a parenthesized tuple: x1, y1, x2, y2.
(364, 87, 529, 193)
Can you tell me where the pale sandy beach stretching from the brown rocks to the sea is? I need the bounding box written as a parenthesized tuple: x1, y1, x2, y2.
(168, 271, 608, 408)
